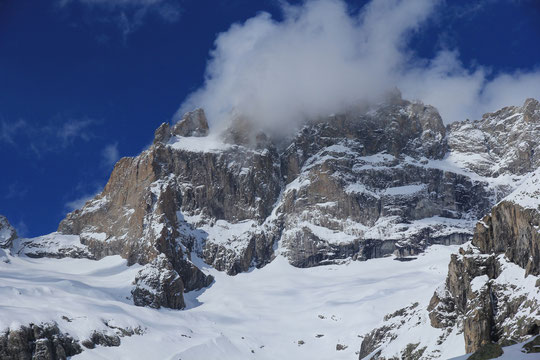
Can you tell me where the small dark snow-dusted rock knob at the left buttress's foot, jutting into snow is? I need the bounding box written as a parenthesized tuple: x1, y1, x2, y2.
(131, 254, 185, 309)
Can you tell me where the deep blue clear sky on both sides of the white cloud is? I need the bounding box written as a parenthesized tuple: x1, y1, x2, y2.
(0, 0, 540, 236)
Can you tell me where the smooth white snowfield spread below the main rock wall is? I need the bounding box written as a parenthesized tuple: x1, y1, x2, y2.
(0, 240, 464, 360)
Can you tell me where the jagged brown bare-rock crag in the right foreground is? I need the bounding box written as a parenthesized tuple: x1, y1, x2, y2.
(428, 197, 540, 353)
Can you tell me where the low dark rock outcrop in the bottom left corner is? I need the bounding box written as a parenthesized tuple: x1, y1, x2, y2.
(0, 324, 82, 360)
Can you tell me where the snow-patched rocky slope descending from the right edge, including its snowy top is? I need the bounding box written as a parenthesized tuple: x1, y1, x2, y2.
(361, 166, 540, 359)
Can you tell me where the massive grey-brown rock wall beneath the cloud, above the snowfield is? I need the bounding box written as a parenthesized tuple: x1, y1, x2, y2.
(58, 96, 538, 306)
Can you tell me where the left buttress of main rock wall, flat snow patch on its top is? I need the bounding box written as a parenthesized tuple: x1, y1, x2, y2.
(59, 114, 280, 280)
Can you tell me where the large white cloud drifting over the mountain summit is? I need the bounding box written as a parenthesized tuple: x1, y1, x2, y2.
(177, 0, 540, 132)
